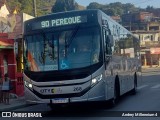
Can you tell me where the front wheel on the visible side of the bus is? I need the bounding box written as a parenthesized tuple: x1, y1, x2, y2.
(110, 76, 120, 107)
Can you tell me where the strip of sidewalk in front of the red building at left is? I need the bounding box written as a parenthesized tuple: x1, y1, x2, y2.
(0, 94, 27, 111)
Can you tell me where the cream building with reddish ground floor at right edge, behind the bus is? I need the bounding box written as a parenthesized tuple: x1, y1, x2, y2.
(133, 31, 160, 67)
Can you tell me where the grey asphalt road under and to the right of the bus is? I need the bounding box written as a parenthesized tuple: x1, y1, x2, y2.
(7, 70, 160, 120)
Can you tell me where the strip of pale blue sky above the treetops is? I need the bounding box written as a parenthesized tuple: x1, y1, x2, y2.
(75, 0, 160, 8)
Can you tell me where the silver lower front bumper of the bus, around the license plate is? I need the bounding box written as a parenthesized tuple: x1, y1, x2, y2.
(25, 81, 106, 104)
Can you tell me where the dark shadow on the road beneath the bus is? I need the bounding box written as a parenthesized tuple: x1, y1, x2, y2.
(45, 93, 138, 117)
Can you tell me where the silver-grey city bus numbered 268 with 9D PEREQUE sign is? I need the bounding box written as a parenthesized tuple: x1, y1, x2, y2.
(23, 9, 141, 107)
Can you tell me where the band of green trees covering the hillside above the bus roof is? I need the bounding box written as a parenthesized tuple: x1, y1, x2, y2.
(6, 0, 160, 16)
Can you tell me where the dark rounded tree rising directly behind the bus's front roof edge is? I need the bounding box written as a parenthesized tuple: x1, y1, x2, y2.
(51, 0, 78, 13)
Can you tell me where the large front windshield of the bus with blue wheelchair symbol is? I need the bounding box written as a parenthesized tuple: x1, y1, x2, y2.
(24, 27, 102, 71)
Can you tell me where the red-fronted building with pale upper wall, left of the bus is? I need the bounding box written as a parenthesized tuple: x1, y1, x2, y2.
(0, 0, 33, 96)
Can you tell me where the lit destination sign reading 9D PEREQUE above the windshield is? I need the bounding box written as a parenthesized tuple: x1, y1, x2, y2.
(32, 15, 87, 30)
